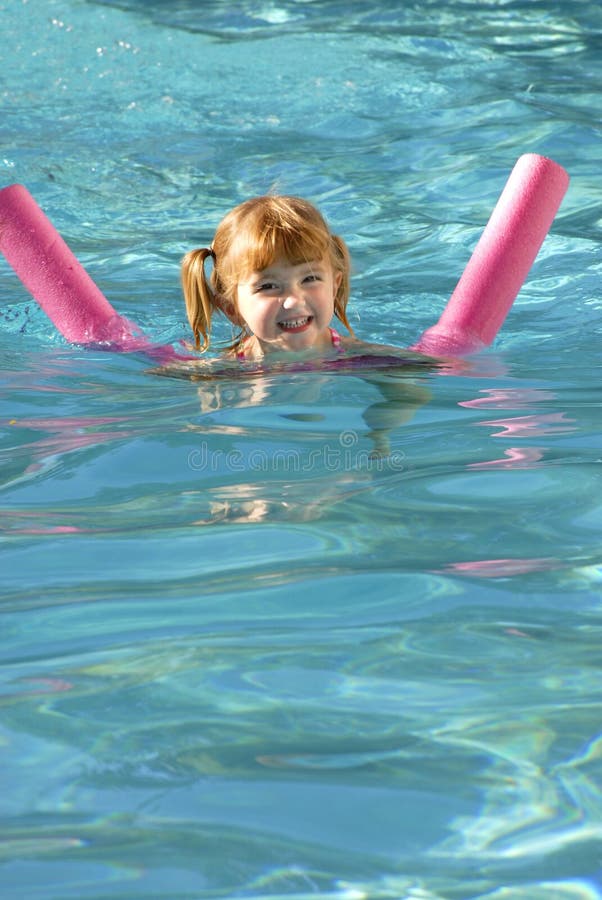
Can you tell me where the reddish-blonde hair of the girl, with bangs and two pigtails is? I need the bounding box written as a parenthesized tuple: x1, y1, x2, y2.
(182, 195, 353, 350)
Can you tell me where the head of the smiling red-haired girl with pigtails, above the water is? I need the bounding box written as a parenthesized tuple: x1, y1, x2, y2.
(182, 196, 353, 360)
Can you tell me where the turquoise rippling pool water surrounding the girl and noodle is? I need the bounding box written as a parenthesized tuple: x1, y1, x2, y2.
(0, 0, 602, 900)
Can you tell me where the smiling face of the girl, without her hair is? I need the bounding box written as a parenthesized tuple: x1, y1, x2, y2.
(232, 257, 342, 355)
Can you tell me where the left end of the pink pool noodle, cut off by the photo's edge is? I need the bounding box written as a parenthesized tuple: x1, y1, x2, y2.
(0, 184, 156, 350)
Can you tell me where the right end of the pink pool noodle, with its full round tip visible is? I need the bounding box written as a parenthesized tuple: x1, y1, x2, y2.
(412, 153, 569, 355)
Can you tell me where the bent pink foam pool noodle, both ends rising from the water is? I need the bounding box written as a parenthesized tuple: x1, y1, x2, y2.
(0, 153, 569, 361)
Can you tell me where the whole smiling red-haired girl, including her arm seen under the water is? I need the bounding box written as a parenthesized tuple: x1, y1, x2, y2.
(182, 196, 434, 456)
